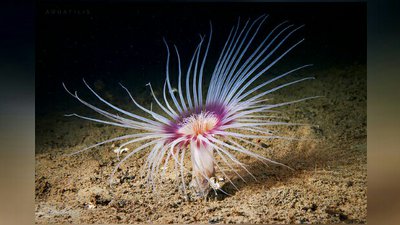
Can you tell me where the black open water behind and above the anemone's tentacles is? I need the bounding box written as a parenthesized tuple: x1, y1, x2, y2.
(36, 2, 366, 116)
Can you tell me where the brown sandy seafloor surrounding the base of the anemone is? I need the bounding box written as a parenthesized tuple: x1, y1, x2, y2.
(35, 61, 367, 223)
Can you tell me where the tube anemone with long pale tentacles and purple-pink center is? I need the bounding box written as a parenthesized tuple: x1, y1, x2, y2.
(63, 15, 318, 196)
